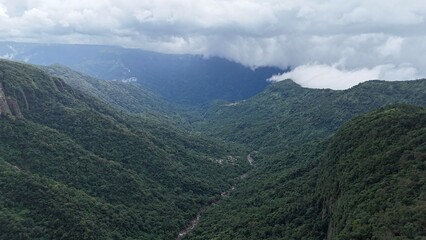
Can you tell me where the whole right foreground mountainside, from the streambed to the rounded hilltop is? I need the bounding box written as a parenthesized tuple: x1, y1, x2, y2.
(188, 105, 426, 239)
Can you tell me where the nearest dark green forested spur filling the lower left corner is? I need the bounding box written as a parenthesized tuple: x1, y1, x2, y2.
(0, 121, 168, 239)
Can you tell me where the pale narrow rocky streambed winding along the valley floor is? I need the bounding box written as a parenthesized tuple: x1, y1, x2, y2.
(176, 151, 256, 240)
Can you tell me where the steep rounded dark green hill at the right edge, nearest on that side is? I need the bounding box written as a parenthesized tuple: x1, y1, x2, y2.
(320, 106, 426, 239)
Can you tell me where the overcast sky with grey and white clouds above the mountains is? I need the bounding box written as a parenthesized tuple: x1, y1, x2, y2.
(0, 0, 426, 89)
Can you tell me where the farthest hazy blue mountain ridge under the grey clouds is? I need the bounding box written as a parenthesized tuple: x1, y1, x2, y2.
(0, 42, 283, 104)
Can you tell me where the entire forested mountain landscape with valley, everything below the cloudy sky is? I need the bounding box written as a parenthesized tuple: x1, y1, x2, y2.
(0, 43, 426, 239)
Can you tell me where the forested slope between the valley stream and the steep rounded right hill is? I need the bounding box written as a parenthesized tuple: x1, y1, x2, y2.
(188, 143, 327, 239)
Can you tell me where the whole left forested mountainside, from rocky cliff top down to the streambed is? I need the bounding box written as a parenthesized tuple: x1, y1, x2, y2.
(0, 60, 249, 239)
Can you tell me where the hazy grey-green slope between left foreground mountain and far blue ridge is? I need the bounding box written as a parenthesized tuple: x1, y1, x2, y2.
(38, 64, 195, 128)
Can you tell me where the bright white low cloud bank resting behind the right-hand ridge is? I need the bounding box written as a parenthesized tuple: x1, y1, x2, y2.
(269, 64, 418, 90)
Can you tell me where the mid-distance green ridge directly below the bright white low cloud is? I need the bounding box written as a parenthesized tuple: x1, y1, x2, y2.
(198, 79, 426, 153)
